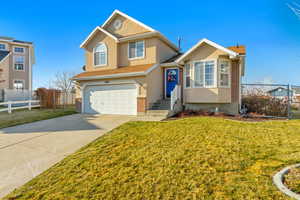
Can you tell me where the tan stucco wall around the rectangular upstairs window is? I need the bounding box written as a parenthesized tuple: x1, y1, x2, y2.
(118, 38, 158, 66)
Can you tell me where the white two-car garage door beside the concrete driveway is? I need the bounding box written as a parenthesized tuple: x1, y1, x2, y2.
(84, 84, 137, 115)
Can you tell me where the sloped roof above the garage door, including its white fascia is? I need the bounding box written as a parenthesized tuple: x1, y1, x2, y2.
(72, 64, 159, 80)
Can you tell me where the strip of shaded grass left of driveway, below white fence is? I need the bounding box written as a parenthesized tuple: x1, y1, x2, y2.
(0, 107, 76, 128)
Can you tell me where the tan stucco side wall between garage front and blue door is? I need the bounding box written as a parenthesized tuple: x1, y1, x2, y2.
(146, 67, 163, 106)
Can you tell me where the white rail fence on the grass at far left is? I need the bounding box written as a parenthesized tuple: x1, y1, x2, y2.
(0, 100, 40, 114)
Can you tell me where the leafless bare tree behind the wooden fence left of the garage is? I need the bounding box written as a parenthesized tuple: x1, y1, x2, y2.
(54, 72, 74, 107)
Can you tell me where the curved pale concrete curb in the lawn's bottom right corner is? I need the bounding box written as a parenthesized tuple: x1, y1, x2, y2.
(273, 164, 300, 200)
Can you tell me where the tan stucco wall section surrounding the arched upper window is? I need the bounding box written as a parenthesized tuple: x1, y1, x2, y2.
(85, 31, 118, 71)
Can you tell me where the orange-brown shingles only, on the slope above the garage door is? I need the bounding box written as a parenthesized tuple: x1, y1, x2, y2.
(73, 64, 154, 79)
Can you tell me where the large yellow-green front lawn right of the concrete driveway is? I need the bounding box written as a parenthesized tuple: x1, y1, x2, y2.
(5, 117, 300, 200)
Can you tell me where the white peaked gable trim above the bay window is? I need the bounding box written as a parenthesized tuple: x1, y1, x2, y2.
(175, 38, 239, 63)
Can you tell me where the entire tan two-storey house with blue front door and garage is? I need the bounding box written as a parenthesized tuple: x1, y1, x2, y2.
(73, 10, 245, 115)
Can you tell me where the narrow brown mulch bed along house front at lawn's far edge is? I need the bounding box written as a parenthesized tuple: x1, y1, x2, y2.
(166, 110, 285, 122)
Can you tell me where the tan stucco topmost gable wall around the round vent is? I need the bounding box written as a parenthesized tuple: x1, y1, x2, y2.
(104, 15, 149, 37)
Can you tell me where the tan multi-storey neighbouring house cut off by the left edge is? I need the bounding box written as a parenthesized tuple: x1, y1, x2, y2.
(0, 37, 35, 91)
